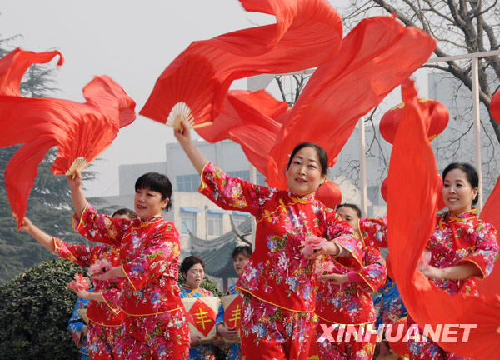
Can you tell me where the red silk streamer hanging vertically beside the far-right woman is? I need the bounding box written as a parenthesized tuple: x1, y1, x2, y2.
(387, 79, 500, 359)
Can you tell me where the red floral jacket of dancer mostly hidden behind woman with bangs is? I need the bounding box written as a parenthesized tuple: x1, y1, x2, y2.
(54, 238, 125, 326)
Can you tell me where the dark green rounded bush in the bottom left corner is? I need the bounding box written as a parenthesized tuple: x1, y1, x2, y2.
(0, 259, 82, 360)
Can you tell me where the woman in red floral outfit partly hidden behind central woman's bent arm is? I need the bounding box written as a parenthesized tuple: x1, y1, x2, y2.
(316, 204, 387, 360)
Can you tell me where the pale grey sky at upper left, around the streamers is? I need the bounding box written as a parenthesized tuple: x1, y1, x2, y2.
(0, 0, 424, 196)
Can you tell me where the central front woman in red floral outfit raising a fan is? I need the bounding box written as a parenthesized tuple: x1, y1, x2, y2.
(175, 124, 362, 360)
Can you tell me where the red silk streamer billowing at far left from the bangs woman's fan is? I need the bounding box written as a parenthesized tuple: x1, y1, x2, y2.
(0, 49, 135, 229)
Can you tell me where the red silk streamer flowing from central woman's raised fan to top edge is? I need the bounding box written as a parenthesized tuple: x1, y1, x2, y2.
(140, 0, 342, 127)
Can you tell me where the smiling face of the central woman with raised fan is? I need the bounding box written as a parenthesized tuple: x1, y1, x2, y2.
(286, 147, 326, 196)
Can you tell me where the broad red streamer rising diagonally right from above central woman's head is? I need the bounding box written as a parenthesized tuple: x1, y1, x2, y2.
(268, 17, 436, 188)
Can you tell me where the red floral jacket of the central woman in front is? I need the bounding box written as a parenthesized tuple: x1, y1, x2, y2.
(199, 163, 362, 311)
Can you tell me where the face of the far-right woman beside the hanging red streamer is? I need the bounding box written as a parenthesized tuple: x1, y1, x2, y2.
(443, 168, 477, 215)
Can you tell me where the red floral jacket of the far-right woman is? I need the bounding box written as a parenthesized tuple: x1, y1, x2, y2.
(427, 209, 498, 295)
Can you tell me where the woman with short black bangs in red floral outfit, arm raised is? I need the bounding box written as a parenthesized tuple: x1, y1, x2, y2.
(68, 172, 189, 360)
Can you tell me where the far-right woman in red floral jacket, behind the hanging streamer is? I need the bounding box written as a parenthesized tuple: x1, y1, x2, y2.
(408, 163, 498, 360)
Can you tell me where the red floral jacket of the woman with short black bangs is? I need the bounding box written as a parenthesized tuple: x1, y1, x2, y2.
(76, 205, 182, 316)
